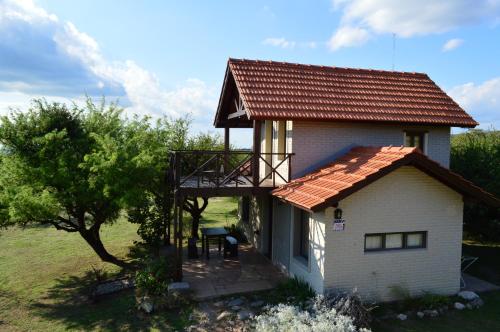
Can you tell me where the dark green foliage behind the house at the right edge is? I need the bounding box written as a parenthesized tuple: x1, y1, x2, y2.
(450, 130, 500, 240)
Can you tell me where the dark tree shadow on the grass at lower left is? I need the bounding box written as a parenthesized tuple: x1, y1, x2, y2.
(31, 268, 187, 331)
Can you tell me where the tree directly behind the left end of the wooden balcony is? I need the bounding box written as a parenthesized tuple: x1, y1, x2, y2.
(127, 124, 223, 249)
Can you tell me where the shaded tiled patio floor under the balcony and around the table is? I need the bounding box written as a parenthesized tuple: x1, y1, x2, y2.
(182, 244, 285, 300)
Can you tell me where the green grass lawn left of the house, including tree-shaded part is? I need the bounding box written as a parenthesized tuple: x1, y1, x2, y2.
(0, 198, 236, 331)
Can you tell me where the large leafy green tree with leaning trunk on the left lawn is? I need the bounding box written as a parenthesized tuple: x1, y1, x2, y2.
(0, 99, 141, 266)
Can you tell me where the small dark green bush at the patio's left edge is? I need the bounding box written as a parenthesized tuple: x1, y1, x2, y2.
(135, 257, 174, 295)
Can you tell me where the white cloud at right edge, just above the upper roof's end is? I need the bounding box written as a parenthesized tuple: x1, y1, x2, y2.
(448, 77, 500, 129)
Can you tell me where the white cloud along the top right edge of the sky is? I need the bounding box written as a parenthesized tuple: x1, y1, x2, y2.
(333, 0, 500, 46)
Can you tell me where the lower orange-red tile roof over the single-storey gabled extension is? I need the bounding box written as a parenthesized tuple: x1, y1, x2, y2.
(272, 147, 500, 211)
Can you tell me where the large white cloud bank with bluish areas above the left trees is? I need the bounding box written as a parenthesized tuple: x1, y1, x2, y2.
(0, 0, 216, 120)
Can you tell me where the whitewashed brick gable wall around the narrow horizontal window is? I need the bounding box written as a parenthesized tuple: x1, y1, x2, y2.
(312, 166, 463, 300)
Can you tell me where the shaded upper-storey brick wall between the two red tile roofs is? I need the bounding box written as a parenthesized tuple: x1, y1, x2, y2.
(290, 121, 450, 177)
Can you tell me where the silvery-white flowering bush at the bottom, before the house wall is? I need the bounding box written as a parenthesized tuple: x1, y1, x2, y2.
(254, 303, 369, 332)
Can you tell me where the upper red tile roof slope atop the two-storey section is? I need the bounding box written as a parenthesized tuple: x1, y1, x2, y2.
(228, 59, 478, 127)
